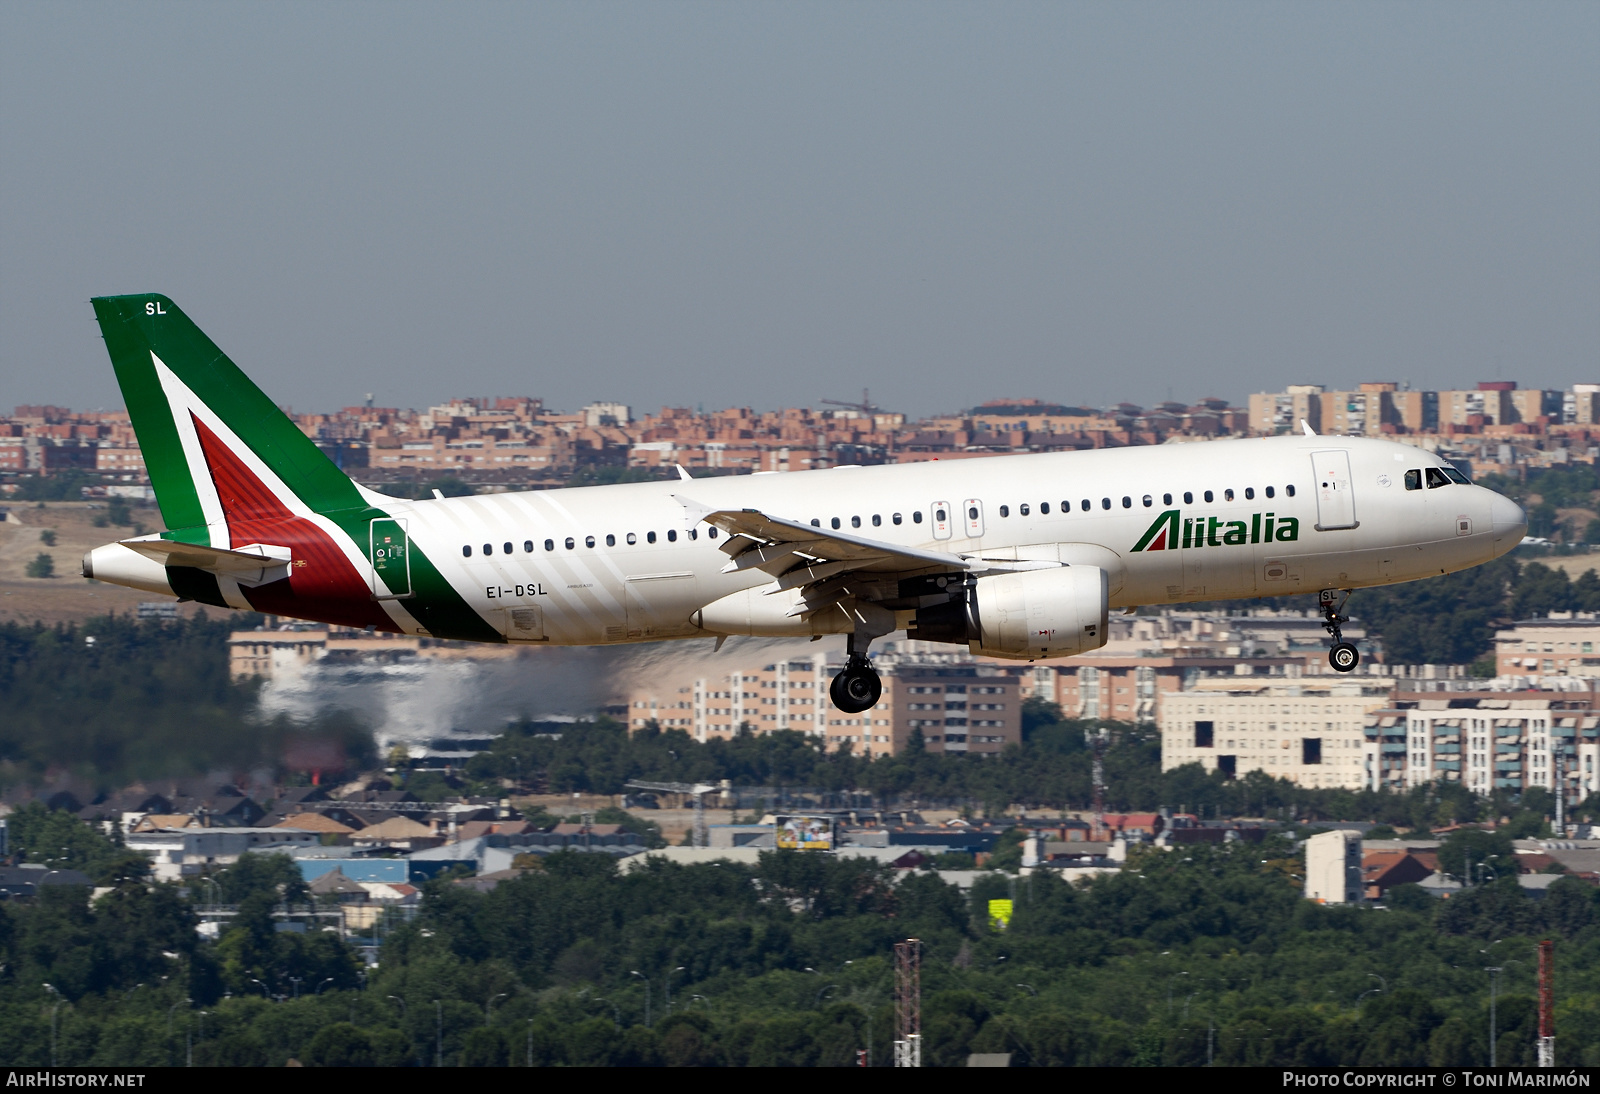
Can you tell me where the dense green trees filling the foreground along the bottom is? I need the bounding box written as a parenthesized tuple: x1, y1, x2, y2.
(0, 822, 1600, 1067)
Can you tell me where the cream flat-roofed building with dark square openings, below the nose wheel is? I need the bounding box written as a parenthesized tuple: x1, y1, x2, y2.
(1160, 678, 1394, 790)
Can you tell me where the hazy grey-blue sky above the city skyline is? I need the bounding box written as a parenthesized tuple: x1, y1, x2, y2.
(0, 0, 1600, 413)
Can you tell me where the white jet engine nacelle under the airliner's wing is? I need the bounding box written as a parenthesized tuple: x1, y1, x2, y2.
(906, 566, 1107, 661)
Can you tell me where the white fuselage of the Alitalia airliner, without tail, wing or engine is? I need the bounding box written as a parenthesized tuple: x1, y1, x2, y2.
(394, 437, 1522, 645)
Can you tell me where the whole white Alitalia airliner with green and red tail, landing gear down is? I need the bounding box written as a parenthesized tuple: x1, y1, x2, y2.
(83, 294, 1526, 713)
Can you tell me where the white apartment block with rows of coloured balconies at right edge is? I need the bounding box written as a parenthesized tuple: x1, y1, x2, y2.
(1365, 691, 1600, 805)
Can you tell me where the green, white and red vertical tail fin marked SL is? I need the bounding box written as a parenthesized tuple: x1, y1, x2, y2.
(93, 293, 365, 528)
